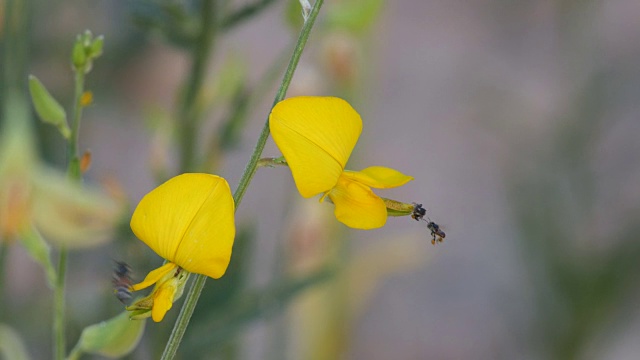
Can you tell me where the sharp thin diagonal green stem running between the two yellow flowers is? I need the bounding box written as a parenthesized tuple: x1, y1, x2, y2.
(161, 0, 324, 360)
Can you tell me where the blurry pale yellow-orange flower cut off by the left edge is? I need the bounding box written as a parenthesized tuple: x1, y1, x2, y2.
(0, 92, 122, 248)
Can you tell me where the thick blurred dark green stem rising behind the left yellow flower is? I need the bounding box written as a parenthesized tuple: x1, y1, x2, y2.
(178, 0, 218, 173)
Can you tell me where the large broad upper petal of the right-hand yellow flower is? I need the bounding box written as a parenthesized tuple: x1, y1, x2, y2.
(269, 96, 362, 197)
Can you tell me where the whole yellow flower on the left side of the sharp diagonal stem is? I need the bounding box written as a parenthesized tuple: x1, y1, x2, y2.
(128, 174, 235, 322)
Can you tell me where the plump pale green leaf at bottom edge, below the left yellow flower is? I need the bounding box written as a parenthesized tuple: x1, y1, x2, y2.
(69, 311, 147, 359)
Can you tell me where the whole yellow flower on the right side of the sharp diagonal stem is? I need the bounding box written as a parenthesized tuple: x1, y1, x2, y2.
(269, 96, 413, 229)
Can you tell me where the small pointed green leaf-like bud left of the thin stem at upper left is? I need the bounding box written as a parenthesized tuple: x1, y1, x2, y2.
(29, 75, 71, 139)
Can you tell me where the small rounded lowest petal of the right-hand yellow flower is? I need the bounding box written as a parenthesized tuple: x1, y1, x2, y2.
(329, 176, 387, 230)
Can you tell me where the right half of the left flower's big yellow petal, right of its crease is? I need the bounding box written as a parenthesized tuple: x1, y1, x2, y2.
(176, 175, 236, 279)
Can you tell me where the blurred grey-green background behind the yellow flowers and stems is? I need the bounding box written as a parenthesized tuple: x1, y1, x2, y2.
(0, 0, 640, 359)
